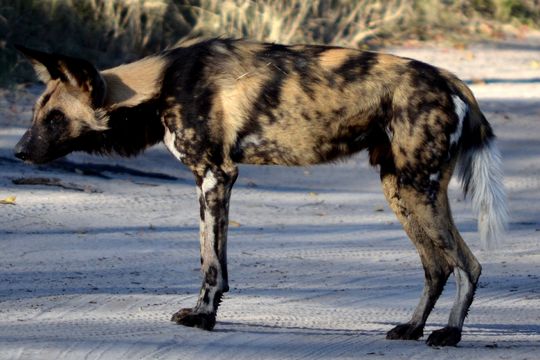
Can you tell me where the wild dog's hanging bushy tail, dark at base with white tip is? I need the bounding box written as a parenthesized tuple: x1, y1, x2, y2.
(452, 79, 508, 249)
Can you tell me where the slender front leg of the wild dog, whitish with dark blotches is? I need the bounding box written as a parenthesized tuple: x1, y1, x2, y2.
(172, 167, 238, 330)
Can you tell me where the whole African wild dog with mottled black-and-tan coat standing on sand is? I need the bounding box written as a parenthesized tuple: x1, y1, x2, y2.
(15, 39, 506, 346)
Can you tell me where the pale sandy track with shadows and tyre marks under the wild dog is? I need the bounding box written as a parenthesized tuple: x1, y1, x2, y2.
(0, 38, 540, 359)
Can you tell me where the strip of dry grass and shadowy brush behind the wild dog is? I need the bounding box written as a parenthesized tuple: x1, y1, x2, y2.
(0, 0, 540, 85)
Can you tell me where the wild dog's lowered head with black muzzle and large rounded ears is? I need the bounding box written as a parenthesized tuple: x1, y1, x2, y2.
(14, 46, 106, 164)
